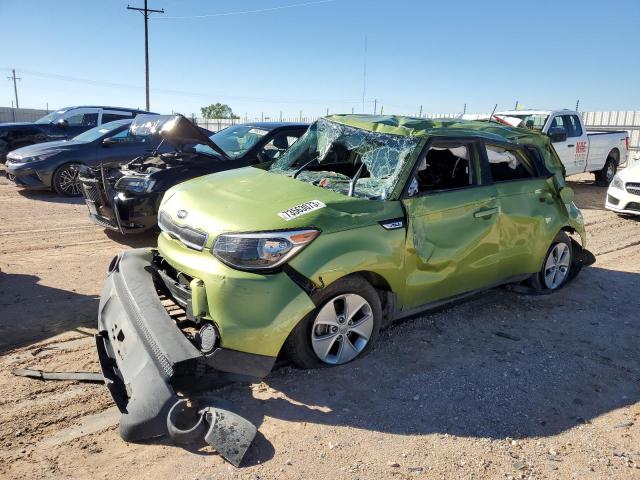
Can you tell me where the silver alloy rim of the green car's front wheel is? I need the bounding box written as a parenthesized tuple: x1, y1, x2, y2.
(311, 293, 374, 365)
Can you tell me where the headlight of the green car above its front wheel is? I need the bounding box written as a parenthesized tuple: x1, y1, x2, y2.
(212, 229, 320, 270)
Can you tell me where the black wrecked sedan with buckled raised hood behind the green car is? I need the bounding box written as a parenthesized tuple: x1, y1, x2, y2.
(80, 115, 308, 234)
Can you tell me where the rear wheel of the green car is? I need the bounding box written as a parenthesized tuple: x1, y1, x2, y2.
(530, 232, 573, 292)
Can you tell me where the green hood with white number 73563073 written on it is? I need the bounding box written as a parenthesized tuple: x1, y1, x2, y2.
(160, 167, 403, 241)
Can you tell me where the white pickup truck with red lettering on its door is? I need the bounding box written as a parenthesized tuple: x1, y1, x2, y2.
(494, 110, 629, 185)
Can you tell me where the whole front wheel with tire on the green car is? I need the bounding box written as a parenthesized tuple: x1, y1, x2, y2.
(285, 275, 382, 368)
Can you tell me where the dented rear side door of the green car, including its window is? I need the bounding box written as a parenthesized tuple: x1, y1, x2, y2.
(485, 143, 559, 281)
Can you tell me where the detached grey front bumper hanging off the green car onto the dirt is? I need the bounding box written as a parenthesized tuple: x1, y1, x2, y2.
(96, 249, 275, 441)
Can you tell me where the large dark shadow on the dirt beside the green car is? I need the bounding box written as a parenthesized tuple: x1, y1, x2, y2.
(206, 268, 640, 463)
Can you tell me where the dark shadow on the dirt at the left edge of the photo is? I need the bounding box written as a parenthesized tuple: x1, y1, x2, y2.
(0, 271, 99, 354)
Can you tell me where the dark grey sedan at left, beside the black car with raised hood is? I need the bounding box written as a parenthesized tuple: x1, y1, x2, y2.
(6, 119, 170, 196)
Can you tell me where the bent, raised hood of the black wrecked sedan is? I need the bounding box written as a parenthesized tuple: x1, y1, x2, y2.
(129, 115, 227, 157)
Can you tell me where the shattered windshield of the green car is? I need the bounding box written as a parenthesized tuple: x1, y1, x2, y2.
(269, 119, 420, 199)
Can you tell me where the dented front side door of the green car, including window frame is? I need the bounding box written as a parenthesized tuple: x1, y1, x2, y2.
(402, 139, 499, 309)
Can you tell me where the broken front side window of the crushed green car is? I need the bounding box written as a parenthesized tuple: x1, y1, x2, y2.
(407, 143, 476, 196)
